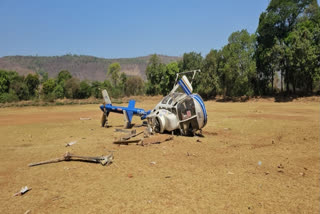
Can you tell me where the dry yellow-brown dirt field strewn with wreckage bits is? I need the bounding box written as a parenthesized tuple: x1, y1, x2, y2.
(0, 98, 320, 213)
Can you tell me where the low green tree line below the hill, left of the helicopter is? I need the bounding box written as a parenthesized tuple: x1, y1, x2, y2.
(0, 63, 144, 103)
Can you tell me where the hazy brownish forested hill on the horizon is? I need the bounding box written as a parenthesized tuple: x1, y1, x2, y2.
(0, 54, 179, 81)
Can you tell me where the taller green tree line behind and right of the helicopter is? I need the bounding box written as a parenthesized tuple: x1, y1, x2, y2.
(146, 0, 320, 99)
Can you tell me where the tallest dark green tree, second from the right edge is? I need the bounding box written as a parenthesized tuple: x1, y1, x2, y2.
(256, 0, 319, 92)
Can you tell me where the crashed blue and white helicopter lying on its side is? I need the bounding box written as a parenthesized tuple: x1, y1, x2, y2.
(100, 70, 208, 136)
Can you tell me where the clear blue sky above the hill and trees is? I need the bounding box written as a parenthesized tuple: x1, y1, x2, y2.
(0, 0, 316, 58)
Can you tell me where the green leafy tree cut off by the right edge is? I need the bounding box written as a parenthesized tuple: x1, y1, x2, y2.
(285, 1, 320, 93)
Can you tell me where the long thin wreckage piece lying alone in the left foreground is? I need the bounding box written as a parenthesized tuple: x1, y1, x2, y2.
(28, 152, 114, 167)
